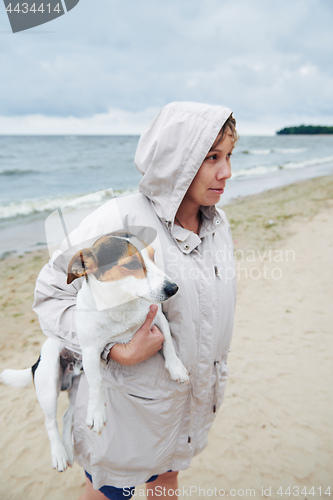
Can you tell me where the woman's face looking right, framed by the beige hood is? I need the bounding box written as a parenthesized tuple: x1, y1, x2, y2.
(184, 130, 235, 208)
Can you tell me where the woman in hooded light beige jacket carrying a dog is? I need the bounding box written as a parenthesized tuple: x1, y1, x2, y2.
(34, 102, 237, 500)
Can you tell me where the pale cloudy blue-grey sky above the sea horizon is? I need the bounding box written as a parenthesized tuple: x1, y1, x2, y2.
(0, 0, 333, 135)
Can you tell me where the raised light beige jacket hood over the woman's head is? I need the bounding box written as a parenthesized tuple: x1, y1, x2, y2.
(135, 102, 232, 222)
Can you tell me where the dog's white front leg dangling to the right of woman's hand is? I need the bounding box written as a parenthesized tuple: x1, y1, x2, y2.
(155, 309, 190, 383)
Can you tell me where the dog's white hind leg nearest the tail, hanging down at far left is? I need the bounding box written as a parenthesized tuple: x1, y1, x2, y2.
(35, 339, 68, 472)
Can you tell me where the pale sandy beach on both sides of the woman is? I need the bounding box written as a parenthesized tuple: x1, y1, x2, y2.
(0, 176, 333, 500)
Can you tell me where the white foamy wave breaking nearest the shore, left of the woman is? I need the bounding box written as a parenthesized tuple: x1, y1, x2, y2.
(0, 188, 137, 220)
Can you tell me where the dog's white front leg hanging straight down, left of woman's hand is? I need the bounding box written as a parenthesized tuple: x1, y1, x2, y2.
(82, 347, 106, 434)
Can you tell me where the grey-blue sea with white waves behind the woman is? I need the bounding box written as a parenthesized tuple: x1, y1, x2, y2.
(0, 135, 333, 258)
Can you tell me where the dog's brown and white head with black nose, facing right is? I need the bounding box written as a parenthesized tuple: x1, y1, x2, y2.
(67, 231, 178, 303)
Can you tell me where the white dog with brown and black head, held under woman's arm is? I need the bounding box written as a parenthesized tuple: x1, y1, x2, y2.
(0, 231, 189, 472)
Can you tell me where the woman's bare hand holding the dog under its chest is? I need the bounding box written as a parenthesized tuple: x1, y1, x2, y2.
(108, 305, 164, 366)
